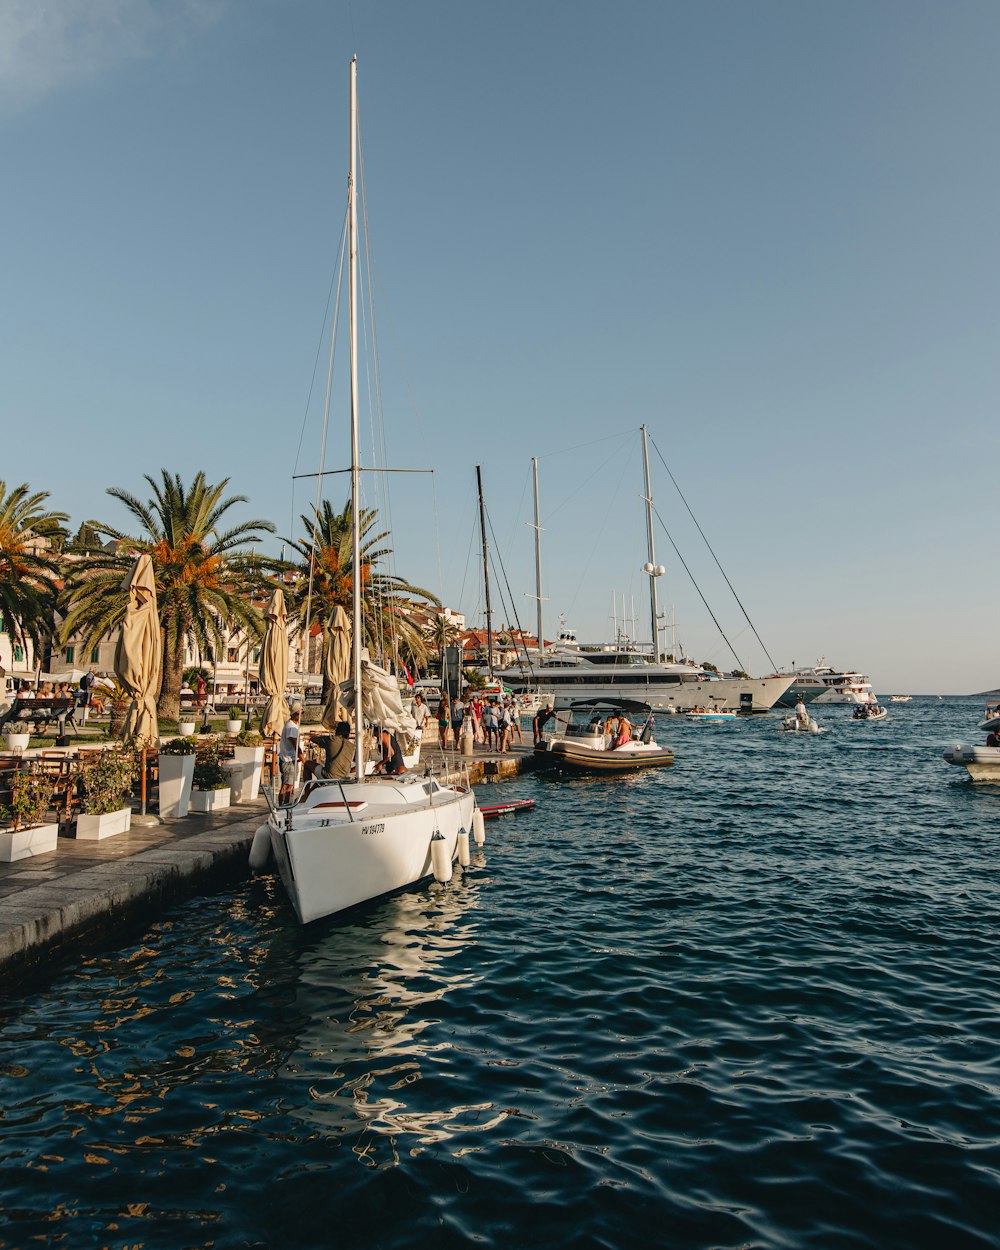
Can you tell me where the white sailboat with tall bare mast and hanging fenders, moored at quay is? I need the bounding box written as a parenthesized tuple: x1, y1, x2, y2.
(256, 58, 475, 924)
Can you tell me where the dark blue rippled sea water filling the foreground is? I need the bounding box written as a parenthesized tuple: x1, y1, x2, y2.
(0, 699, 1000, 1250)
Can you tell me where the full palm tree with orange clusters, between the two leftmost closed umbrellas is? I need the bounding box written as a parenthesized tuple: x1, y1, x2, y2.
(63, 469, 274, 719)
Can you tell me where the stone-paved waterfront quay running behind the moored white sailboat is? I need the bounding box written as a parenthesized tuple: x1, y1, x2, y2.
(0, 735, 540, 990)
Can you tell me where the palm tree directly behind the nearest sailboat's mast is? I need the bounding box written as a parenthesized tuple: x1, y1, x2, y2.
(285, 500, 438, 696)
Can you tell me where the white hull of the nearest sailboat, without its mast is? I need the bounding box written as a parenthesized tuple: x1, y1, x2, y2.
(269, 779, 475, 924)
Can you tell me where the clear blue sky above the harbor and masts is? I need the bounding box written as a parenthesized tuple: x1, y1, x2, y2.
(0, 0, 1000, 693)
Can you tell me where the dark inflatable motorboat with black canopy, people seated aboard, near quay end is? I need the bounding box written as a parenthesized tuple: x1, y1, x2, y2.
(535, 699, 674, 774)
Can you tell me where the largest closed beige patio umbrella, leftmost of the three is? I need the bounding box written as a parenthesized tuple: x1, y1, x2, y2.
(115, 551, 164, 743)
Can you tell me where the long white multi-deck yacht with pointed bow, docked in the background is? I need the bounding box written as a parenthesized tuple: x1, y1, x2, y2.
(498, 630, 794, 713)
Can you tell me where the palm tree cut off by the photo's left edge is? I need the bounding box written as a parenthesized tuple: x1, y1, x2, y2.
(0, 481, 69, 670)
